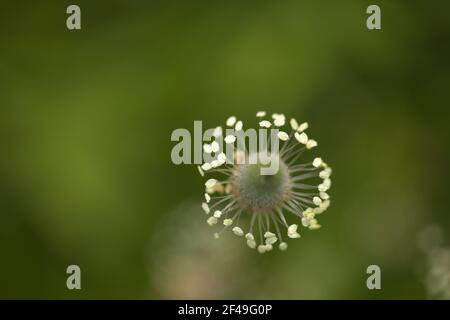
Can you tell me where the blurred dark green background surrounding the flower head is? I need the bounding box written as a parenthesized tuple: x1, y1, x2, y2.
(0, 0, 450, 299)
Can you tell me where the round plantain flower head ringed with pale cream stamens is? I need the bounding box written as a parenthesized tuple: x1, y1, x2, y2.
(199, 111, 332, 253)
